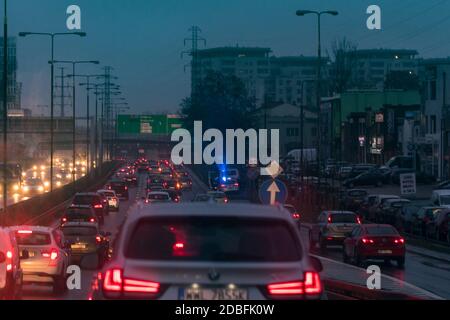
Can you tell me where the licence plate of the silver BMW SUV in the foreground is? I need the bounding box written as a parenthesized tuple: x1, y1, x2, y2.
(180, 288, 248, 300)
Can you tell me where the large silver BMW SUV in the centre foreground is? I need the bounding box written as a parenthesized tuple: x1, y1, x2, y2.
(89, 202, 323, 300)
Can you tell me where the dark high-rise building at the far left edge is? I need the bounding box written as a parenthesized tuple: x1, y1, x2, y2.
(0, 37, 21, 110)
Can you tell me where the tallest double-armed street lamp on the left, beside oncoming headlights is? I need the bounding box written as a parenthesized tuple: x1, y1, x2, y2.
(19, 32, 86, 191)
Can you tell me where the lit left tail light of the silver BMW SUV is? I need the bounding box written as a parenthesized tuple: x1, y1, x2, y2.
(103, 269, 160, 294)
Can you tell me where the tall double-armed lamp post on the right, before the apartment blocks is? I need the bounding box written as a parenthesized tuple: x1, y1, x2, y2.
(296, 10, 339, 180)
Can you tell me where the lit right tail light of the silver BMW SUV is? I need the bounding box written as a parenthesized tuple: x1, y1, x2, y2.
(267, 272, 322, 297)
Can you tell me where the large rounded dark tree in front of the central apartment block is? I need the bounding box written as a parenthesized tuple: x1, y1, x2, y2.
(181, 71, 255, 132)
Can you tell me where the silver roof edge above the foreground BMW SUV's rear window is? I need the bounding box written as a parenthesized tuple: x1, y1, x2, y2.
(128, 202, 291, 222)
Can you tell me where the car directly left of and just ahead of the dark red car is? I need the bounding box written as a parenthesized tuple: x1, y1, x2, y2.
(309, 211, 361, 251)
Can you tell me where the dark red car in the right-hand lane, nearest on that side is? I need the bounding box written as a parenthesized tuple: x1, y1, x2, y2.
(342, 224, 406, 269)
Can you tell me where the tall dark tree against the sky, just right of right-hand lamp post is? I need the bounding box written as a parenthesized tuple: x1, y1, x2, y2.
(330, 37, 357, 93)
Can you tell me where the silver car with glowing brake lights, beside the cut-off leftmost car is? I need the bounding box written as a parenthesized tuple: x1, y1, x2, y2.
(11, 226, 70, 294)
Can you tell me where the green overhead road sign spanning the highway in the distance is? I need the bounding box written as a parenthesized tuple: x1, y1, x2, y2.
(117, 114, 183, 135)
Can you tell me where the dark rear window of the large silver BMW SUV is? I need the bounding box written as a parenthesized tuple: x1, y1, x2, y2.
(125, 216, 302, 262)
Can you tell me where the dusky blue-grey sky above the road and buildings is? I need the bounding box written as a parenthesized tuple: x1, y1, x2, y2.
(9, 0, 450, 114)
